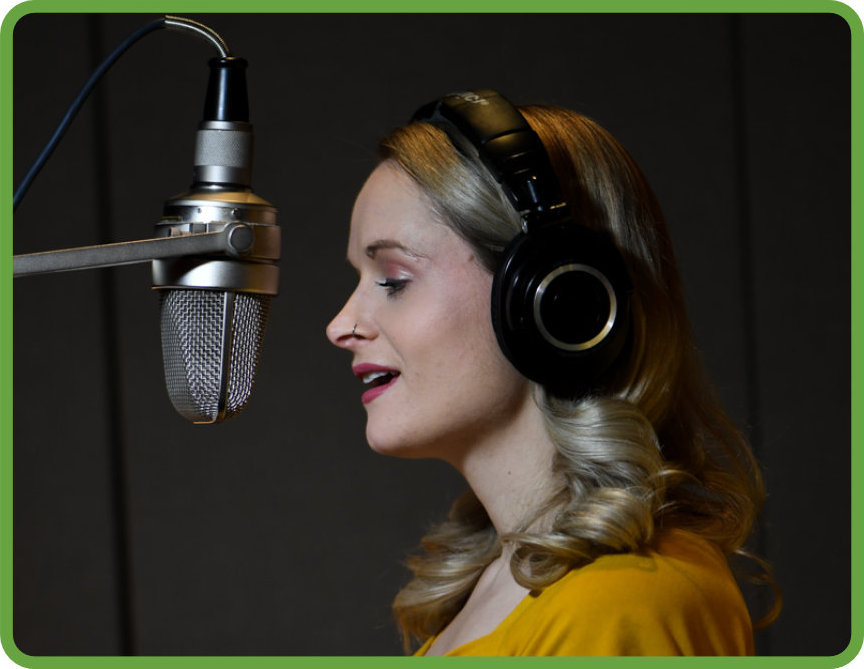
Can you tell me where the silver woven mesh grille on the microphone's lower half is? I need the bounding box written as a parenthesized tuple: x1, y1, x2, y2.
(160, 290, 270, 423)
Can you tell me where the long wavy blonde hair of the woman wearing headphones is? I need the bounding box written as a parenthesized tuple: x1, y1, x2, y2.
(380, 106, 779, 650)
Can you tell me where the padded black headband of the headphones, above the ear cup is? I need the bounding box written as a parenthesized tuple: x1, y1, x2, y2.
(411, 89, 569, 230)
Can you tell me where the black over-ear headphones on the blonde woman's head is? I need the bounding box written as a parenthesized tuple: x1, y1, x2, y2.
(412, 89, 631, 396)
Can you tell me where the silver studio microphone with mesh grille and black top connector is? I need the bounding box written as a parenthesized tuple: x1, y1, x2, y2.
(153, 57, 280, 423)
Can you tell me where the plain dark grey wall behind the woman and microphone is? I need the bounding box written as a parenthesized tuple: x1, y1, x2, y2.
(6, 14, 850, 655)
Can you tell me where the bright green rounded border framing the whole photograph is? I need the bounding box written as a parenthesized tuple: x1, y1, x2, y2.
(0, 0, 864, 669)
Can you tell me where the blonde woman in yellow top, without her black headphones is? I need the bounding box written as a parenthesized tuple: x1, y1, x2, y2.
(327, 91, 776, 655)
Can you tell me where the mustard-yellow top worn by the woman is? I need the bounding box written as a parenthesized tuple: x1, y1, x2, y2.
(415, 530, 753, 656)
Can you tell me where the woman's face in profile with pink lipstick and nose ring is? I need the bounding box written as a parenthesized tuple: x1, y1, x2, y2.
(327, 163, 532, 461)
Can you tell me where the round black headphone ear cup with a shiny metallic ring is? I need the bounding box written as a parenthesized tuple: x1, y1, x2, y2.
(492, 222, 631, 395)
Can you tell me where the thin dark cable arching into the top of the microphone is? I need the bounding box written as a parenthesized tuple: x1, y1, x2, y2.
(12, 15, 231, 212)
